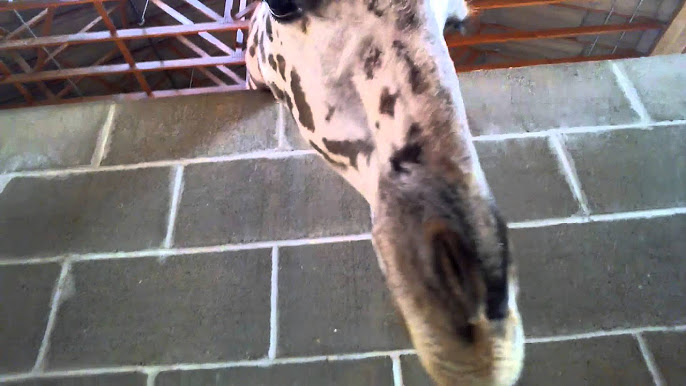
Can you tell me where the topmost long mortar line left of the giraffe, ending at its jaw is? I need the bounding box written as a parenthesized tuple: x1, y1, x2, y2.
(0, 149, 317, 178)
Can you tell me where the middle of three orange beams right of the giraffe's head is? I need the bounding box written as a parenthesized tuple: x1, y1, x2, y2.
(445, 23, 662, 47)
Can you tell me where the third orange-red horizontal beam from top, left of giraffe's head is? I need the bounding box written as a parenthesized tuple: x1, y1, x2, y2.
(0, 55, 245, 84)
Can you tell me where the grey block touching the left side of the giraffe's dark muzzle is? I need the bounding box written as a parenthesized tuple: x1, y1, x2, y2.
(277, 241, 411, 356)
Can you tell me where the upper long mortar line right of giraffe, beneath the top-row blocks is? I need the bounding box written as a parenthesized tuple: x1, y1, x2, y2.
(473, 119, 686, 142)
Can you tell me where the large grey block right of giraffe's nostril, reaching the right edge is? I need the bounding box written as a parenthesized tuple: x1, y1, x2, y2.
(510, 215, 686, 337)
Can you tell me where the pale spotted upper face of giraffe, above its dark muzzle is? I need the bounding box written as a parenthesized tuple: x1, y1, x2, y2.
(247, 1, 484, 206)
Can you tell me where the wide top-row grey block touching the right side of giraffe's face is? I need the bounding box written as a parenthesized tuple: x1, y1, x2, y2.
(459, 62, 639, 135)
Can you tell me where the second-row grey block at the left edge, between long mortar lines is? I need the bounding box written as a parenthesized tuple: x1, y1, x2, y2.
(0, 168, 172, 259)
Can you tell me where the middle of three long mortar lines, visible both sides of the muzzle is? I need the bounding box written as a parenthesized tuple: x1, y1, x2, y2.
(5, 207, 686, 266)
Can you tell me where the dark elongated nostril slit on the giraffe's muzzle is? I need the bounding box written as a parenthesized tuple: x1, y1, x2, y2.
(425, 220, 485, 323)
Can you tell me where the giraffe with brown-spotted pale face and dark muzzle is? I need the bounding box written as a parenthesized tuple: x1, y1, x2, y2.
(246, 0, 524, 385)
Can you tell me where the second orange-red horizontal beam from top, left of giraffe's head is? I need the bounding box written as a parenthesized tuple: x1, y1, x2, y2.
(0, 20, 248, 51)
